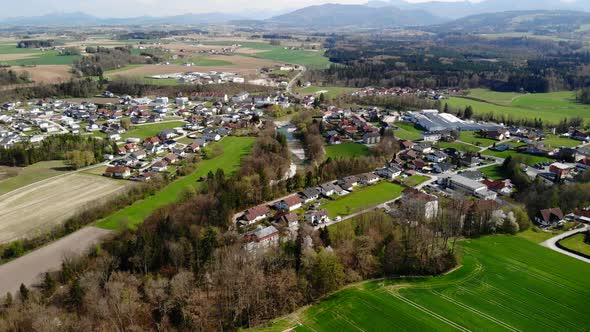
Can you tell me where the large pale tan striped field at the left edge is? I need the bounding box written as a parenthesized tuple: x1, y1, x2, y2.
(0, 173, 130, 243)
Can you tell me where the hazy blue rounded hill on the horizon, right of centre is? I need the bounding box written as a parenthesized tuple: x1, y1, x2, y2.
(268, 4, 444, 29)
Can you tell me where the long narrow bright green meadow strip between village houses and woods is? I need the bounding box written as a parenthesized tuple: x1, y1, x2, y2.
(96, 137, 255, 230)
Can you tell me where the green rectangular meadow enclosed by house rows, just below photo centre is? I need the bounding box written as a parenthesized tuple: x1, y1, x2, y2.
(323, 182, 404, 218)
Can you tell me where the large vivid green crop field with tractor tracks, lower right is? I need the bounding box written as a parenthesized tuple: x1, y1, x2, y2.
(261, 235, 590, 331)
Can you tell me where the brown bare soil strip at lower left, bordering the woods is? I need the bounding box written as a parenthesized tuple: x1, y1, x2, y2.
(0, 227, 111, 296)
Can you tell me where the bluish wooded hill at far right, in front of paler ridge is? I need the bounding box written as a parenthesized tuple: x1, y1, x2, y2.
(426, 10, 590, 35)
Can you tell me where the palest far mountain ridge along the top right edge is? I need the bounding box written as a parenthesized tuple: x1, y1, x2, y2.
(367, 0, 590, 19)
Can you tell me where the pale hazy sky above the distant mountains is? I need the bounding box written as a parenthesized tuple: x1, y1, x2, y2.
(0, 0, 480, 18)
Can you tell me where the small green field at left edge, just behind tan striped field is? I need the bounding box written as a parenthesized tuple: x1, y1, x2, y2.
(0, 160, 70, 195)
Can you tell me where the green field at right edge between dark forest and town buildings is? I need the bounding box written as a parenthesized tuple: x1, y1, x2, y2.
(447, 89, 590, 123)
